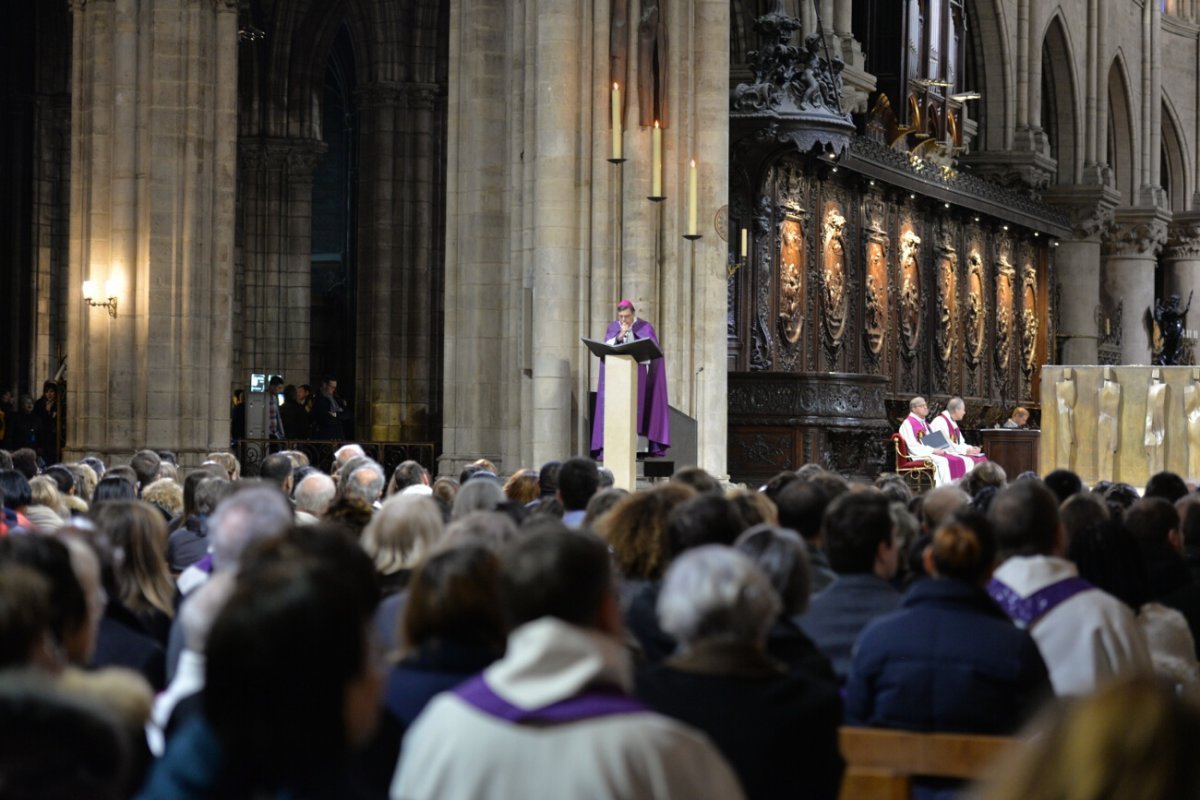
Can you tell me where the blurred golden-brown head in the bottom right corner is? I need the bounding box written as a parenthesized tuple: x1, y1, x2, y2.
(979, 676, 1200, 800)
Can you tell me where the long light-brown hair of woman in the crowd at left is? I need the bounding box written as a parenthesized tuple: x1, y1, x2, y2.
(91, 500, 175, 616)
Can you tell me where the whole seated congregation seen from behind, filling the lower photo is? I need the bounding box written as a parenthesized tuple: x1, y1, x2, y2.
(0, 445, 1200, 800)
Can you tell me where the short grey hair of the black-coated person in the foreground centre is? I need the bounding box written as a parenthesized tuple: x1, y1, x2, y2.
(658, 545, 781, 650)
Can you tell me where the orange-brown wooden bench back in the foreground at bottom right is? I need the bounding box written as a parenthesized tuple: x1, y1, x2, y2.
(839, 726, 1018, 800)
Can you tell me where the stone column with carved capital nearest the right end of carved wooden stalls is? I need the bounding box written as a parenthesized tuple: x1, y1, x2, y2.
(1043, 186, 1120, 365)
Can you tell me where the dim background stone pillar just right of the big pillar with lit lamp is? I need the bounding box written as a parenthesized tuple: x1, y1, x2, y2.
(234, 137, 326, 393)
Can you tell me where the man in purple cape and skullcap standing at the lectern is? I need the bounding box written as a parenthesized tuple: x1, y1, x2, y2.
(592, 300, 671, 461)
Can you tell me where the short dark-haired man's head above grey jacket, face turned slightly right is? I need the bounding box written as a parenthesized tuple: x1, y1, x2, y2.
(823, 489, 899, 579)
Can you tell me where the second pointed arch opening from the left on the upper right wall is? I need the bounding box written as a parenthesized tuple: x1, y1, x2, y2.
(1042, 13, 1084, 184)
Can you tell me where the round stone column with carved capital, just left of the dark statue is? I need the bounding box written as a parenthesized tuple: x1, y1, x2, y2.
(1102, 209, 1168, 365)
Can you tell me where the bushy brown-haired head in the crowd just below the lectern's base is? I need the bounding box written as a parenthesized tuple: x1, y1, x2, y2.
(595, 481, 696, 581)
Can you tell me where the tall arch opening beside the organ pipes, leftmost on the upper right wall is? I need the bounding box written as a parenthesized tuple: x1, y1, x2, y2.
(964, 0, 1016, 150)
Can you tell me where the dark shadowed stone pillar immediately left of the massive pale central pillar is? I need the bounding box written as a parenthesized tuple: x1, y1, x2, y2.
(355, 83, 448, 441)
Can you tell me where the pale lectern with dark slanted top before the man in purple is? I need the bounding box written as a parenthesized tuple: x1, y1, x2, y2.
(583, 337, 662, 492)
